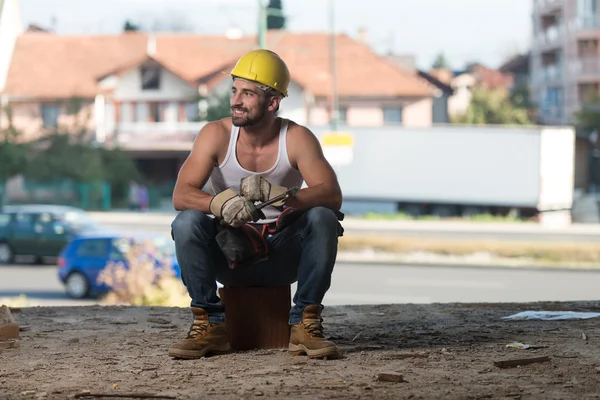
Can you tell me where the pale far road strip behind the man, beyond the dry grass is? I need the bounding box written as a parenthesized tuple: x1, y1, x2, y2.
(91, 212, 600, 242)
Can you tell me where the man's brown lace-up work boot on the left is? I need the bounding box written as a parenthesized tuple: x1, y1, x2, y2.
(169, 307, 231, 358)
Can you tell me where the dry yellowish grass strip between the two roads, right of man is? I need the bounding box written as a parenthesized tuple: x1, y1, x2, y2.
(339, 235, 600, 264)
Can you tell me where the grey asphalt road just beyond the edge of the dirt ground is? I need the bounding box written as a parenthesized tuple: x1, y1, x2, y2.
(0, 263, 600, 306)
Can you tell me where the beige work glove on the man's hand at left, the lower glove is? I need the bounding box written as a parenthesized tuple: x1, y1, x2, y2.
(208, 189, 265, 228)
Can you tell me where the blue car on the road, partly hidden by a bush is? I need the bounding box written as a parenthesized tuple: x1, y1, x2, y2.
(58, 232, 181, 299)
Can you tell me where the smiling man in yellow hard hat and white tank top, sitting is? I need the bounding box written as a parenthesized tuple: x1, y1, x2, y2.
(169, 50, 343, 358)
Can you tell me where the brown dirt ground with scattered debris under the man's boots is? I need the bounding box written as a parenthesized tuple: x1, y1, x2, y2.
(0, 303, 600, 399)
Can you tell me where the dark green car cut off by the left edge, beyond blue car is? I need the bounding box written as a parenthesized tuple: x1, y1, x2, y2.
(0, 204, 103, 264)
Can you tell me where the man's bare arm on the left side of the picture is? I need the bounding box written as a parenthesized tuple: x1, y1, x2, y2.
(173, 122, 220, 213)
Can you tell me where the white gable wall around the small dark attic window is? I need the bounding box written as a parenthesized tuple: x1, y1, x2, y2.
(113, 68, 198, 101)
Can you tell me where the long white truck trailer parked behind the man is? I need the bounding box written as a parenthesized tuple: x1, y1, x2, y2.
(313, 125, 575, 217)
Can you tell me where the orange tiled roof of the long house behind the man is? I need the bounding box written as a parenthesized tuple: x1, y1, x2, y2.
(4, 31, 432, 98)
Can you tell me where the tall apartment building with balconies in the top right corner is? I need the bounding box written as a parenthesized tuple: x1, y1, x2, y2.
(531, 0, 600, 124)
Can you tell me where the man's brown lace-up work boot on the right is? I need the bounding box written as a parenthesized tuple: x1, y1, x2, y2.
(288, 304, 339, 358)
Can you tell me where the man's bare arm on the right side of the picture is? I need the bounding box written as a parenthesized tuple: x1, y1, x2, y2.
(286, 125, 342, 211)
